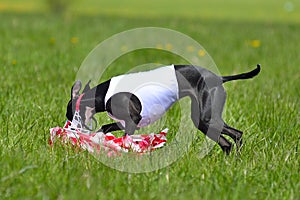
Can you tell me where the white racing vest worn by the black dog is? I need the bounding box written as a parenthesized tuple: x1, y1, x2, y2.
(105, 65, 179, 127)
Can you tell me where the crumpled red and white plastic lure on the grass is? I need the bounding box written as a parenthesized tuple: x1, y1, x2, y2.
(49, 117, 168, 156)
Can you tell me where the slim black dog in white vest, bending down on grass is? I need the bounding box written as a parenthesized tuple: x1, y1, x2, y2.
(66, 64, 260, 154)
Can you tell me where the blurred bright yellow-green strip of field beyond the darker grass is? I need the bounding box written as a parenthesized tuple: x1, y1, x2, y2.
(0, 0, 300, 22)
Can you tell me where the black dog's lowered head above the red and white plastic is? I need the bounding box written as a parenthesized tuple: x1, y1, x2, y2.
(66, 81, 95, 127)
